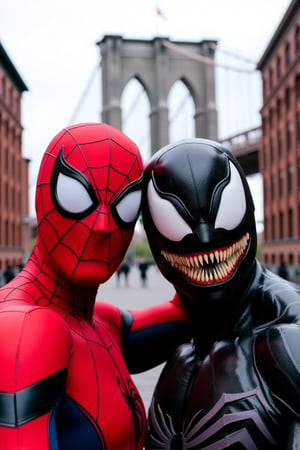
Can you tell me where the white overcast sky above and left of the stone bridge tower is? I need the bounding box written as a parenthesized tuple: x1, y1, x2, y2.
(0, 0, 290, 218)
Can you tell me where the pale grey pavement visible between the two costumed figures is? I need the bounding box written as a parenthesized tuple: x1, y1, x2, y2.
(97, 266, 174, 412)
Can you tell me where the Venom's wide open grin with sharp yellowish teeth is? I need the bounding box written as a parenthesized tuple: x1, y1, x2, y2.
(161, 232, 250, 284)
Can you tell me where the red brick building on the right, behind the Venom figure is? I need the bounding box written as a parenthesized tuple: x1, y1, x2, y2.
(257, 0, 300, 278)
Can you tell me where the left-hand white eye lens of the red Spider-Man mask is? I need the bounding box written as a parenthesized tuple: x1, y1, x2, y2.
(56, 173, 93, 214)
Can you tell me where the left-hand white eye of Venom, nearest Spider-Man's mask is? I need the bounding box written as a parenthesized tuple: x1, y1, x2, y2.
(147, 181, 192, 242)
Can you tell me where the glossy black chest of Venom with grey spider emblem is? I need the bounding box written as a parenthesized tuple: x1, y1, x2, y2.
(146, 342, 287, 450)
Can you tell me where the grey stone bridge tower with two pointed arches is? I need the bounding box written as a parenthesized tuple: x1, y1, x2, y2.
(98, 35, 218, 154)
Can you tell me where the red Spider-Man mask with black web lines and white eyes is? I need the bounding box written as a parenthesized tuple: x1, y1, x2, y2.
(36, 123, 142, 285)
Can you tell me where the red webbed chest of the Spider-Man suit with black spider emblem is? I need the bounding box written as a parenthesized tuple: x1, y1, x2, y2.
(66, 324, 145, 450)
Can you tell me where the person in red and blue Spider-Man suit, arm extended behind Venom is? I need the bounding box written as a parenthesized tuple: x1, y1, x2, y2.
(0, 123, 187, 450)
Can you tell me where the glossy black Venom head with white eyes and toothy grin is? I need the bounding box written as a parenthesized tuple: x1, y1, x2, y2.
(143, 139, 256, 302)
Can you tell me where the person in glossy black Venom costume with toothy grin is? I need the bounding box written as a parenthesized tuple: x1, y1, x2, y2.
(143, 139, 300, 450)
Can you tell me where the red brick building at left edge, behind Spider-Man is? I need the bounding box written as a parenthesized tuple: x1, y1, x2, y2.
(0, 43, 30, 271)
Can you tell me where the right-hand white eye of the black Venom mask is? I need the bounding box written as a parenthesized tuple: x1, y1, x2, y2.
(215, 162, 246, 231)
